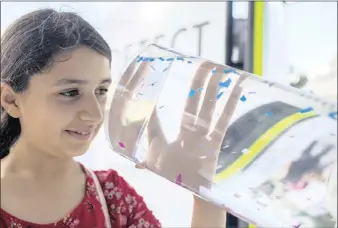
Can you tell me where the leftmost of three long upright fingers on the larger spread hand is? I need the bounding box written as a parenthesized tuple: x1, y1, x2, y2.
(181, 62, 215, 127)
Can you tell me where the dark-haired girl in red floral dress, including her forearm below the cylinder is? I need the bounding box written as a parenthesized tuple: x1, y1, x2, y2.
(0, 9, 225, 228)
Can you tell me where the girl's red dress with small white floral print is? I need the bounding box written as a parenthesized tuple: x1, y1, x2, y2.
(0, 166, 161, 228)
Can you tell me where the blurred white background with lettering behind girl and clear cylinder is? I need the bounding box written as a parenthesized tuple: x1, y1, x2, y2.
(1, 2, 337, 227)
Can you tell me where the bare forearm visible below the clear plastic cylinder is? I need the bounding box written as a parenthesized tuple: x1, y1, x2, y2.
(191, 196, 226, 228)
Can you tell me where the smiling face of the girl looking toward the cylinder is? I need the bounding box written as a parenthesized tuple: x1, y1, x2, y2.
(10, 47, 111, 157)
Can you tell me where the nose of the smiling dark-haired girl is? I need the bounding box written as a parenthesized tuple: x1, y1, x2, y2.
(80, 96, 104, 125)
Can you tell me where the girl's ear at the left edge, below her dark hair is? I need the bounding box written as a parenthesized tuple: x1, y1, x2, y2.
(0, 83, 20, 118)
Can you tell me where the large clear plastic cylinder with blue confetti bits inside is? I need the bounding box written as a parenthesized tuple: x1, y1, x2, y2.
(106, 45, 337, 227)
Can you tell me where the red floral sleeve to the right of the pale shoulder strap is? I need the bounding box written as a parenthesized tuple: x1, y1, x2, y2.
(95, 170, 161, 228)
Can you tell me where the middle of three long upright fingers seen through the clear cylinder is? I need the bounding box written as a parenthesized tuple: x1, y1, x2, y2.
(197, 66, 224, 134)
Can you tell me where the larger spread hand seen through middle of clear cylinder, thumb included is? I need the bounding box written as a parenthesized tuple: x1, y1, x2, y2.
(143, 62, 244, 193)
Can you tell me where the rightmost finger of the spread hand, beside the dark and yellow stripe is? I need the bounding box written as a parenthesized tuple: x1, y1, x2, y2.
(211, 76, 245, 141)
